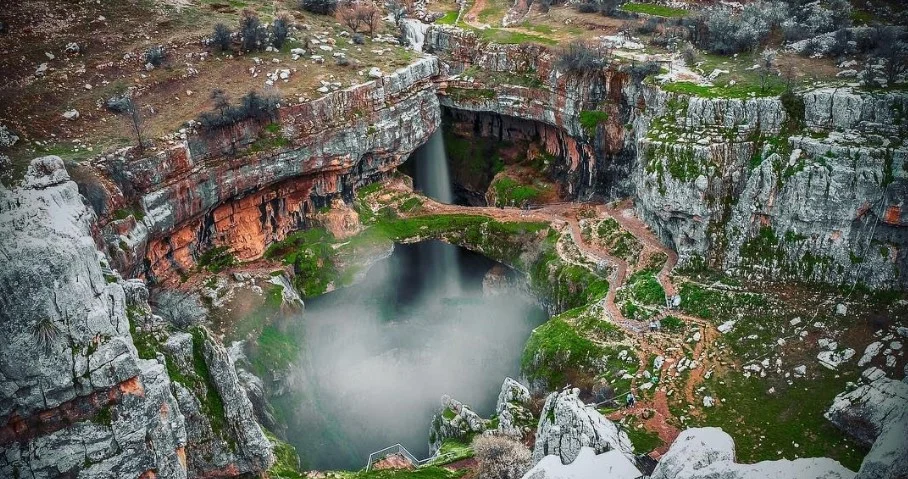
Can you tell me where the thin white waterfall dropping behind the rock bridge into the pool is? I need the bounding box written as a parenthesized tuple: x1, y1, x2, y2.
(416, 129, 461, 297)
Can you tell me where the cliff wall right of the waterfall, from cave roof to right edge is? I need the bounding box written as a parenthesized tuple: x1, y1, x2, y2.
(425, 27, 908, 287)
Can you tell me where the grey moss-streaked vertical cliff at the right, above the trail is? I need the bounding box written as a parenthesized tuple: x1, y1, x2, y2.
(629, 84, 908, 287)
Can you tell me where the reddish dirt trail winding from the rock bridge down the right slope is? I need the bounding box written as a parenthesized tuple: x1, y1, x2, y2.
(372, 183, 719, 459)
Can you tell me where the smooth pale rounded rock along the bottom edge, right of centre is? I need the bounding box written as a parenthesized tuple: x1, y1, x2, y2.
(651, 427, 854, 479)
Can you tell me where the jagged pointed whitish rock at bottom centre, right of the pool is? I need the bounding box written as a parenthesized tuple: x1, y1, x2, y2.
(533, 388, 634, 464)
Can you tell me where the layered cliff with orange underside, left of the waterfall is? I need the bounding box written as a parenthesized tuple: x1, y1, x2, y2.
(84, 58, 440, 279)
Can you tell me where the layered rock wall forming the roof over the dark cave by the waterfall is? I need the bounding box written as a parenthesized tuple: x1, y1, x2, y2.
(425, 27, 630, 197)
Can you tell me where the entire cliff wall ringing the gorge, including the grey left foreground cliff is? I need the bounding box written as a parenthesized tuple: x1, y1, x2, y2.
(0, 21, 908, 478)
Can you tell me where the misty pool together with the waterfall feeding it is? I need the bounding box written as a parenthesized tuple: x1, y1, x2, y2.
(273, 132, 546, 470)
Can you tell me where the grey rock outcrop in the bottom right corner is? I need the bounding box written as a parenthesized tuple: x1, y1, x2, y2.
(826, 368, 908, 479)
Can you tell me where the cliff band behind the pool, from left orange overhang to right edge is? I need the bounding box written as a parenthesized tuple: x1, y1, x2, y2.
(65, 27, 908, 287)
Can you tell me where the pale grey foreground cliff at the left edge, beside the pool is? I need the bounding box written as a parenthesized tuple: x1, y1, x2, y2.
(0, 157, 273, 478)
